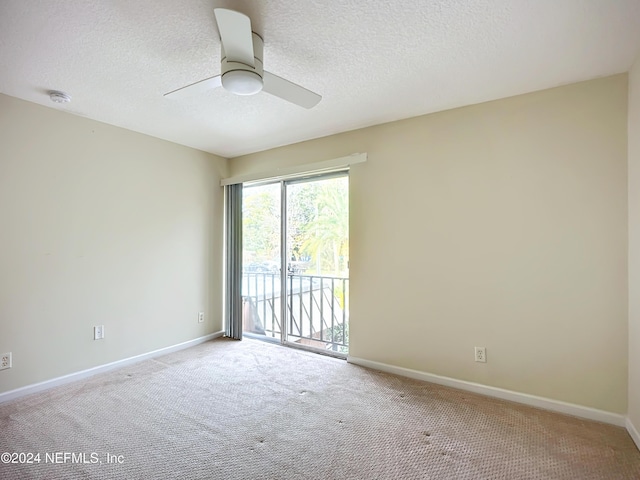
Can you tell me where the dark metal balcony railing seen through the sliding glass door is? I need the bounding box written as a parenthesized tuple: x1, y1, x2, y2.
(242, 272, 349, 354)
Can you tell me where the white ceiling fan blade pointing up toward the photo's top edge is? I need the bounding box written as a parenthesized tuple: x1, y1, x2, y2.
(213, 8, 255, 67)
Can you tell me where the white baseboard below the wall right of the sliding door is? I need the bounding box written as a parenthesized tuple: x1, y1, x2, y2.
(347, 356, 624, 428)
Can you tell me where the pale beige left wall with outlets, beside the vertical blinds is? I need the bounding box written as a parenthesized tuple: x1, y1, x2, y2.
(0, 95, 227, 392)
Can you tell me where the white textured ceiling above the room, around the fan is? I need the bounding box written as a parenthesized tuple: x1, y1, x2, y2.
(0, 0, 640, 158)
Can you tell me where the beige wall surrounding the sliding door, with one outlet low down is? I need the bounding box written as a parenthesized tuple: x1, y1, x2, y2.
(229, 75, 627, 413)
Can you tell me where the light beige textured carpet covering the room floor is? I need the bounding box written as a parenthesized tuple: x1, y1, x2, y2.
(0, 339, 640, 480)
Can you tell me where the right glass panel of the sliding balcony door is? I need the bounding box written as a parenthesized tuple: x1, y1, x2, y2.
(285, 174, 349, 354)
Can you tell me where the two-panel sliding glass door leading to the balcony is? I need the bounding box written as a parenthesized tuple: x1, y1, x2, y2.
(242, 172, 349, 355)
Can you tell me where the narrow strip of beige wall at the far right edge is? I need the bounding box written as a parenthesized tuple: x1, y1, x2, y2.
(629, 58, 640, 430)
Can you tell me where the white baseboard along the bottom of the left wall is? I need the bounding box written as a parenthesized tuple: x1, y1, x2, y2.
(0, 332, 224, 403)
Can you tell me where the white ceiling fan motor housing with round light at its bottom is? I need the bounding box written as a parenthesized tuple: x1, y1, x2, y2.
(221, 32, 264, 95)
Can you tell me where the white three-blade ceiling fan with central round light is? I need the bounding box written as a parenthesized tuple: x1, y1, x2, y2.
(164, 8, 322, 108)
